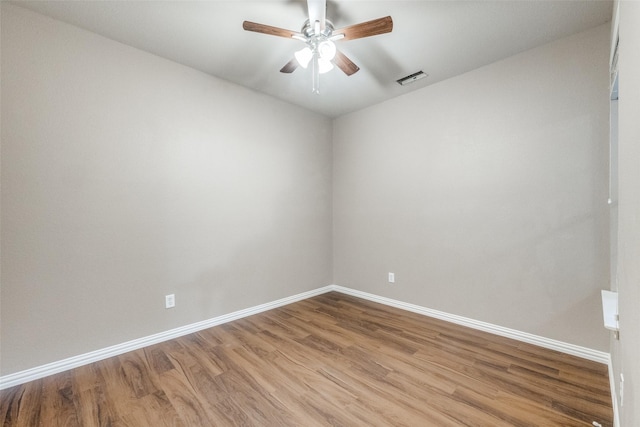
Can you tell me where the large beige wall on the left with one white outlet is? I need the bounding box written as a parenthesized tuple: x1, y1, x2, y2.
(1, 2, 331, 374)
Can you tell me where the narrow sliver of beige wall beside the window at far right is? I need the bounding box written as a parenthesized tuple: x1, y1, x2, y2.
(614, 1, 640, 427)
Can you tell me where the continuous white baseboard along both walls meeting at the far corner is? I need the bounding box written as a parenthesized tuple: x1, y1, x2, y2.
(0, 285, 615, 392)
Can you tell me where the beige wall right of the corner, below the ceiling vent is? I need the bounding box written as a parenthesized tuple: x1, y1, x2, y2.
(333, 24, 610, 351)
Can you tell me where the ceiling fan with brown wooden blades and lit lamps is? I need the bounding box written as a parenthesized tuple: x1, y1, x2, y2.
(242, 0, 393, 93)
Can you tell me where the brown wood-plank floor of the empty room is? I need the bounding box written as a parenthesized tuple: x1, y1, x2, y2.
(0, 293, 613, 427)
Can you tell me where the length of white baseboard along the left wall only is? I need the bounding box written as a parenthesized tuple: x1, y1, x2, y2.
(0, 286, 333, 390)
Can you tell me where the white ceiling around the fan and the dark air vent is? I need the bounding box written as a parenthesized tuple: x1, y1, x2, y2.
(8, 0, 612, 117)
